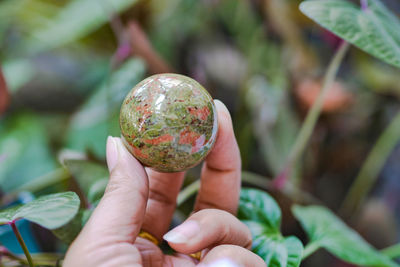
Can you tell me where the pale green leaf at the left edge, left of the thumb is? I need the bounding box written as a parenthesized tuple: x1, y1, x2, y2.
(0, 192, 80, 229)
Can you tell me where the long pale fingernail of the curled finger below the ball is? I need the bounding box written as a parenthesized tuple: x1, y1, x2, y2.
(163, 221, 200, 244)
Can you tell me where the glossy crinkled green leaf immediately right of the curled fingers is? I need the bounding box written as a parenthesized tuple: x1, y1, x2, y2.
(238, 189, 303, 267)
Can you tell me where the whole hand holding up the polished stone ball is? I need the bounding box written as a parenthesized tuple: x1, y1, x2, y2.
(63, 100, 266, 267)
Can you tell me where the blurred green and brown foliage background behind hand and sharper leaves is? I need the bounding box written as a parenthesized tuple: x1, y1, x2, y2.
(0, 0, 400, 266)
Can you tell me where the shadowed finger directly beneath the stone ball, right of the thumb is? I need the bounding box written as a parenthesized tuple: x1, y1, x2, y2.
(142, 169, 184, 240)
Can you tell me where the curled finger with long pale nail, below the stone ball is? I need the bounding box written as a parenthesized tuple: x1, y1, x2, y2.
(164, 209, 251, 254)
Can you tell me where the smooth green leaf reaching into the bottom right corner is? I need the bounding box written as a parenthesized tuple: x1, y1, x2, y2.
(292, 205, 399, 266)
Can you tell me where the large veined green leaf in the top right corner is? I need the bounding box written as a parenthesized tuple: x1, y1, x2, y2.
(300, 0, 400, 68)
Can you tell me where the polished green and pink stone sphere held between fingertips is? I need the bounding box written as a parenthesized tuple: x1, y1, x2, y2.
(120, 73, 218, 172)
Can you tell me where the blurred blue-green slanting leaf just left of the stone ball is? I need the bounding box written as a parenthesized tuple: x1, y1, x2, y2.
(67, 59, 145, 158)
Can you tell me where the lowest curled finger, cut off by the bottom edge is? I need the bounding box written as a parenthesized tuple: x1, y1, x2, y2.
(198, 245, 267, 267)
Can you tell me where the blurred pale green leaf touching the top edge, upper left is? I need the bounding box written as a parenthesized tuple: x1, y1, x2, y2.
(29, 0, 138, 52)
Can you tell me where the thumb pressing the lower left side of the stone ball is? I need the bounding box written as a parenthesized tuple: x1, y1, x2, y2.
(85, 136, 149, 243)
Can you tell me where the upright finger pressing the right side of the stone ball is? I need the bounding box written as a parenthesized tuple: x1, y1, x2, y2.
(194, 100, 241, 214)
